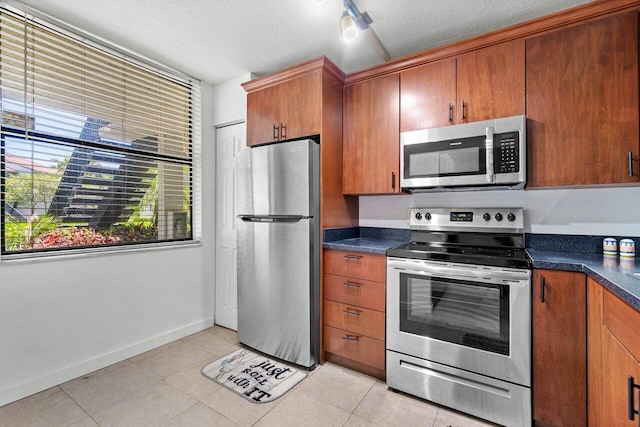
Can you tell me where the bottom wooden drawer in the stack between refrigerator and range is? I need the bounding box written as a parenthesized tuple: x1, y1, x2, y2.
(324, 326, 385, 370)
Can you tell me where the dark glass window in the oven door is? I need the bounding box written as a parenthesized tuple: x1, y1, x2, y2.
(400, 273, 509, 356)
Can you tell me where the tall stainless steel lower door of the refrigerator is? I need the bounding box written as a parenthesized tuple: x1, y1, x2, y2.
(238, 217, 319, 367)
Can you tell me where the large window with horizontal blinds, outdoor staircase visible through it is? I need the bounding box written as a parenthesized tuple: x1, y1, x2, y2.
(0, 8, 200, 255)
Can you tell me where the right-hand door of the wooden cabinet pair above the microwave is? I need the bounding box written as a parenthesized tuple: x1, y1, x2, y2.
(457, 39, 525, 123)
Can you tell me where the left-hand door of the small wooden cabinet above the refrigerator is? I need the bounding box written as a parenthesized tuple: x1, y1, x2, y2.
(247, 86, 280, 146)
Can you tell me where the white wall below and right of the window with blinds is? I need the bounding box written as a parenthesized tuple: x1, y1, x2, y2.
(0, 85, 215, 406)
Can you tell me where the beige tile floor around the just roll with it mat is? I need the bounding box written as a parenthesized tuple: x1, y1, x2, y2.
(0, 326, 490, 427)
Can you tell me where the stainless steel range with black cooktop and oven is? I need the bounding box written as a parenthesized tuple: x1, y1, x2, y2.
(387, 208, 531, 426)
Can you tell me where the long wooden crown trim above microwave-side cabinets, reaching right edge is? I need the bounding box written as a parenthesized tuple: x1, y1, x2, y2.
(344, 0, 640, 85)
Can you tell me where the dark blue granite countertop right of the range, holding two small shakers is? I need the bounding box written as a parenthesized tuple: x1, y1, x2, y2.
(527, 248, 640, 311)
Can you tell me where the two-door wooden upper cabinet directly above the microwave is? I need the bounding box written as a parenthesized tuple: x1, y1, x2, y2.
(400, 39, 525, 132)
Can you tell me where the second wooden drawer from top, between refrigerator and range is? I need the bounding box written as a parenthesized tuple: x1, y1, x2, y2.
(324, 274, 385, 311)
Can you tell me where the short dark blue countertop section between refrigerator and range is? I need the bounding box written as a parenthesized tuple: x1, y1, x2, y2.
(322, 227, 409, 255)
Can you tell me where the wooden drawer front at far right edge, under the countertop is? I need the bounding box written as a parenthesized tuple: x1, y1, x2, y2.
(602, 290, 640, 360)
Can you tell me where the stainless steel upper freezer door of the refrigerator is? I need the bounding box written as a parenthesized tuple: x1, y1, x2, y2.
(236, 140, 319, 216)
